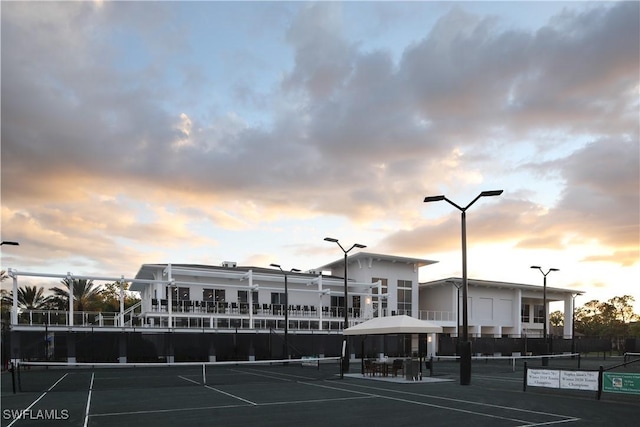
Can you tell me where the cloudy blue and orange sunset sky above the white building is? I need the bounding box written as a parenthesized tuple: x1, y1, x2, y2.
(0, 1, 640, 312)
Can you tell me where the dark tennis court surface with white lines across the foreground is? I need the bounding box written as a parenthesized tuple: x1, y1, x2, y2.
(2, 358, 640, 427)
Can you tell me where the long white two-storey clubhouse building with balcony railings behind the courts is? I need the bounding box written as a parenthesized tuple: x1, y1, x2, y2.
(3, 252, 579, 360)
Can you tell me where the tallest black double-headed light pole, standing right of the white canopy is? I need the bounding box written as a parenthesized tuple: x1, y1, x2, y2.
(424, 190, 502, 385)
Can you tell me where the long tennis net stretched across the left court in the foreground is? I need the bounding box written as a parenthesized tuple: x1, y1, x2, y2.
(17, 357, 340, 391)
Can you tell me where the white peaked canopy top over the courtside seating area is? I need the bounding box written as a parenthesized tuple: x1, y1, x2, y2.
(344, 315, 442, 335)
